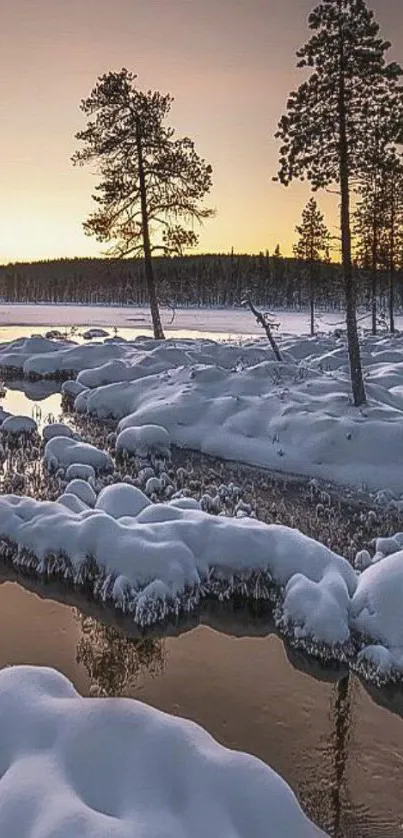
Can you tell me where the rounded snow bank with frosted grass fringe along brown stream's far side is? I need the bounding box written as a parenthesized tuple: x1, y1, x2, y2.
(0, 488, 356, 646)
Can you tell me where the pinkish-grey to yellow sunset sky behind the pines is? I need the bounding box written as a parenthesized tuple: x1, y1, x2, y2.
(0, 0, 403, 264)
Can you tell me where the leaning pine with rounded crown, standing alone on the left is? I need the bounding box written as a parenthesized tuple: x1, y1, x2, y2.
(73, 69, 216, 338)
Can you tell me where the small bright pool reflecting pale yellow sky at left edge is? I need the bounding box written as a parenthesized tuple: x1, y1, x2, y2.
(1, 381, 61, 427)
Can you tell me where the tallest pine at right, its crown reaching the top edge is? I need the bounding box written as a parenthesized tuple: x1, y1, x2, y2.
(277, 0, 402, 407)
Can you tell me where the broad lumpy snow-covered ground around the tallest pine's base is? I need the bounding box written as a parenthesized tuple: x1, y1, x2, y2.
(0, 335, 403, 496)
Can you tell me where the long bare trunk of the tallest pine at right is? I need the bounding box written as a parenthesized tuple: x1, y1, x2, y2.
(338, 27, 366, 407)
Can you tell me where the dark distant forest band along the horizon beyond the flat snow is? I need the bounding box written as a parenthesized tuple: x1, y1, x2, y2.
(0, 253, 403, 311)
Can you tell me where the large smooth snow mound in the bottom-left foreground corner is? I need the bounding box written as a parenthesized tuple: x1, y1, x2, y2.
(0, 667, 323, 838)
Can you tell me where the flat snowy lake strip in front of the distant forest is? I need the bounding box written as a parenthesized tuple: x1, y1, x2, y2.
(0, 303, 403, 337)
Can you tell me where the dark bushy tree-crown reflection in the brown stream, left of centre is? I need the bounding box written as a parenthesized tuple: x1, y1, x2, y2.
(76, 615, 165, 696)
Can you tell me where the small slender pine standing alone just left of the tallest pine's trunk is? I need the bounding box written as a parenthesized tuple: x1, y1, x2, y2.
(294, 198, 330, 337)
